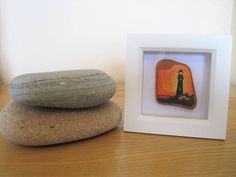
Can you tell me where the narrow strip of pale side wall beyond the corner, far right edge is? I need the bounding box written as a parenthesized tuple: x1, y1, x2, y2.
(231, 0, 236, 85)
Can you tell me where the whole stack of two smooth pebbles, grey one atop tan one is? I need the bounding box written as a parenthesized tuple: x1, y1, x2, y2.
(0, 70, 122, 146)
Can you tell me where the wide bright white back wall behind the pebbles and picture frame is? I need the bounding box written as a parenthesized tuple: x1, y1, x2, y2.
(0, 0, 233, 82)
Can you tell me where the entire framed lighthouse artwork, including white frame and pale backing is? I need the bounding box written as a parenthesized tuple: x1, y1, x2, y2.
(124, 34, 231, 139)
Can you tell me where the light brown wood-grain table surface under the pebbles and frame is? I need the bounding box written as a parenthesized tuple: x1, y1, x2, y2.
(0, 84, 236, 177)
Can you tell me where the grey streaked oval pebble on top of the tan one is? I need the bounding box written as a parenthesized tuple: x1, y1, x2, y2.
(9, 69, 116, 108)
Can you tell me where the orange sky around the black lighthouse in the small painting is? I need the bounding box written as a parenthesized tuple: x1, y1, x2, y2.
(157, 64, 194, 96)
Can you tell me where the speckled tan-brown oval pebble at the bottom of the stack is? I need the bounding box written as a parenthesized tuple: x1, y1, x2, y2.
(0, 101, 122, 146)
